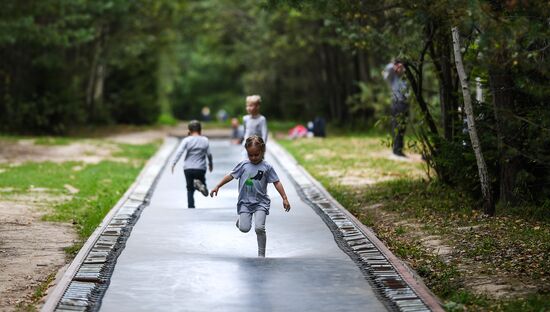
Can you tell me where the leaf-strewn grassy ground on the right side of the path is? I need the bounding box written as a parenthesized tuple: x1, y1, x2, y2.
(280, 132, 550, 311)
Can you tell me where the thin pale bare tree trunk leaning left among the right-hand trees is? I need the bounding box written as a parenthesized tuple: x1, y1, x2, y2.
(452, 27, 495, 216)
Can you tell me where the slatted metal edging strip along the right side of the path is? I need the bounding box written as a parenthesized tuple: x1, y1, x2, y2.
(267, 140, 444, 312)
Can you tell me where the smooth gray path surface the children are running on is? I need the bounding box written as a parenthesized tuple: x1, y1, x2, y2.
(100, 141, 386, 312)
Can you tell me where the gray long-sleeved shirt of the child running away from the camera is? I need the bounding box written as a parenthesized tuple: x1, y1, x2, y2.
(172, 135, 212, 170)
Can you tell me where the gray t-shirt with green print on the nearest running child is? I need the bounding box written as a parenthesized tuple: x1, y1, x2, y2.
(230, 159, 279, 214)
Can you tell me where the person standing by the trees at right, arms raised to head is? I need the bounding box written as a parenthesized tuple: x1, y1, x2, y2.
(382, 60, 409, 157)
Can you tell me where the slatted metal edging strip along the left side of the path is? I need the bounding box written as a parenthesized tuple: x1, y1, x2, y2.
(41, 137, 179, 312)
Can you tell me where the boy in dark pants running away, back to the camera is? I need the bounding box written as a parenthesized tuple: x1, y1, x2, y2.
(172, 120, 213, 208)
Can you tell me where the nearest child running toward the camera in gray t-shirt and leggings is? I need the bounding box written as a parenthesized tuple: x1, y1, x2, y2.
(210, 135, 290, 257)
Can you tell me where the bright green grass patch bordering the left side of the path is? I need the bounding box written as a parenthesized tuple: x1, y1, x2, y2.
(0, 144, 158, 239)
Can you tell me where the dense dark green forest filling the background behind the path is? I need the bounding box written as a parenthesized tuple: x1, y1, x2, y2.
(0, 0, 550, 227)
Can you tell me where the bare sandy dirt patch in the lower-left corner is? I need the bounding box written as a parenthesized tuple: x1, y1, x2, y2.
(0, 189, 77, 311)
